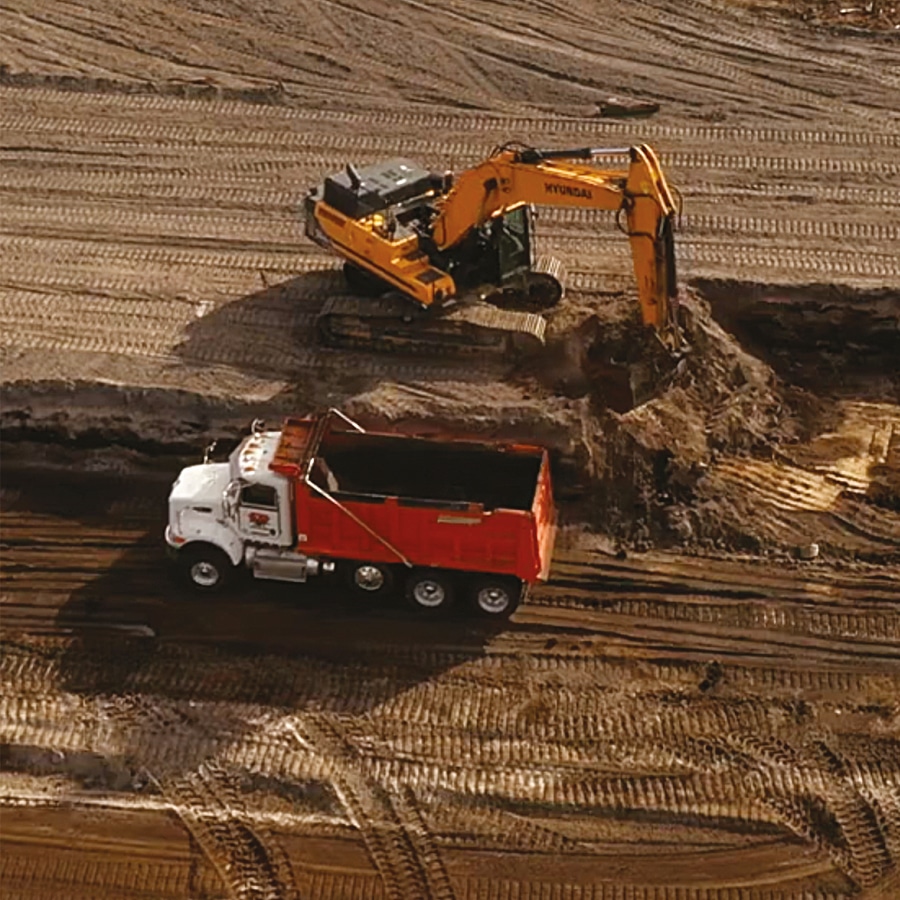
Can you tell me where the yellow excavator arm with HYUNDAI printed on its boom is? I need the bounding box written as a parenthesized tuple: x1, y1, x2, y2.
(432, 144, 681, 348)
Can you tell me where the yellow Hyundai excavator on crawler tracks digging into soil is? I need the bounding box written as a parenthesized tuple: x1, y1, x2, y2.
(304, 143, 682, 353)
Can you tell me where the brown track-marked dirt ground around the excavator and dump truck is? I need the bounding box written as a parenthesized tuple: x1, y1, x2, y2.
(0, 0, 900, 900)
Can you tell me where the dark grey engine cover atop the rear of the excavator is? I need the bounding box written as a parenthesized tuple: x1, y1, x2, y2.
(322, 159, 440, 219)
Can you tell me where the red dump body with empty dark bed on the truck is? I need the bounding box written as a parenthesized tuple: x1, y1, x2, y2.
(271, 415, 556, 582)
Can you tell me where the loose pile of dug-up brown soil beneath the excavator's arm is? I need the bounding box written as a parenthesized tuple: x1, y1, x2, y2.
(345, 295, 816, 547)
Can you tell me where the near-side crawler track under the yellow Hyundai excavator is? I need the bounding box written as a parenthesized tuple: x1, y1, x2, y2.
(316, 294, 547, 358)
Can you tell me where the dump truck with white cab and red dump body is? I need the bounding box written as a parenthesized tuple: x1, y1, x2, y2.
(166, 410, 556, 618)
